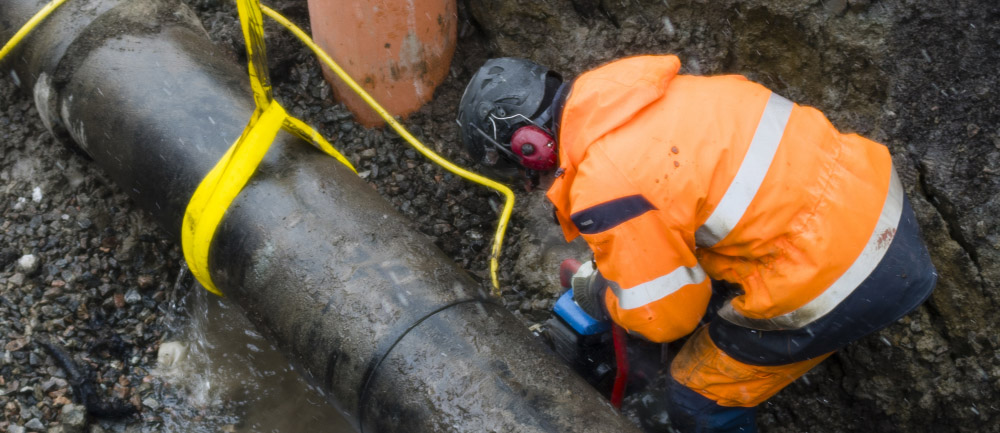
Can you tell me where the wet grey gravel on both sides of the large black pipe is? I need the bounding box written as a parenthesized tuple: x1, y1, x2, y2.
(0, 0, 554, 433)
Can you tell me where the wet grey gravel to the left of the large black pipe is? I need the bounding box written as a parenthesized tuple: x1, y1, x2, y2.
(0, 80, 181, 432)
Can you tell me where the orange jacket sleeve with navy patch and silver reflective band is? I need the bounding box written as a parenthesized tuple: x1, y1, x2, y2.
(570, 156, 712, 342)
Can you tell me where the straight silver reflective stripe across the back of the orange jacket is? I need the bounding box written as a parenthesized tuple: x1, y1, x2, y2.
(694, 93, 794, 248)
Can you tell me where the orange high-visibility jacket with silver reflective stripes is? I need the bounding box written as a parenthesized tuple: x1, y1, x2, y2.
(548, 56, 903, 342)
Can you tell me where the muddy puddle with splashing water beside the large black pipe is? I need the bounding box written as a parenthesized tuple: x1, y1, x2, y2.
(153, 272, 354, 433)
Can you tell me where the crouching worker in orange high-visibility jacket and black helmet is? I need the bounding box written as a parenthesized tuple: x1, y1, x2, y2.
(458, 55, 937, 432)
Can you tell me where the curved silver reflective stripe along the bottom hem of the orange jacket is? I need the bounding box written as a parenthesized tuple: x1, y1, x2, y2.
(719, 168, 903, 331)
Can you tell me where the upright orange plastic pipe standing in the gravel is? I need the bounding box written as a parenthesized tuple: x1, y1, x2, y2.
(309, 0, 458, 127)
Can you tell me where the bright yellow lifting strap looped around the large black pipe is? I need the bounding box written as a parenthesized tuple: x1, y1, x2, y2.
(181, 0, 357, 296)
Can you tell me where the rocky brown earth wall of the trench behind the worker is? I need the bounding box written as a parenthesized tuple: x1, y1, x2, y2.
(469, 0, 1000, 431)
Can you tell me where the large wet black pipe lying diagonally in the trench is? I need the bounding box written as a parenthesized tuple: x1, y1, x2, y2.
(0, 0, 632, 432)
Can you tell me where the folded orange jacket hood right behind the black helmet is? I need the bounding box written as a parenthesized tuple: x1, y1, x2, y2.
(547, 55, 681, 240)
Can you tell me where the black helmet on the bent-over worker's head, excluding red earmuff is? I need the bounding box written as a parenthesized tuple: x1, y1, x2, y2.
(458, 57, 562, 169)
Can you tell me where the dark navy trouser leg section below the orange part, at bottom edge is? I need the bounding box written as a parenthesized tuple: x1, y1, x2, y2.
(667, 378, 757, 433)
